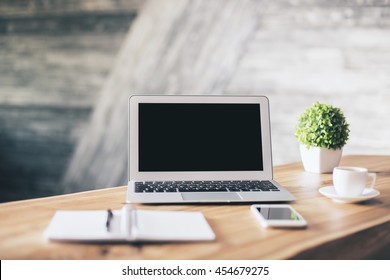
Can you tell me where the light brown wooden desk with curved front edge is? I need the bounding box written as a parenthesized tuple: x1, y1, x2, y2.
(0, 156, 390, 259)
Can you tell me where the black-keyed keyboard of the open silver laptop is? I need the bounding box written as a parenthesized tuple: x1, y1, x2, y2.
(135, 181, 280, 193)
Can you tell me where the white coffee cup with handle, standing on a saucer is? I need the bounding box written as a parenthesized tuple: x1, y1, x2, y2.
(333, 166, 376, 197)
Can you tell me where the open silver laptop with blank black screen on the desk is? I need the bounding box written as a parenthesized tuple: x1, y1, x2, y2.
(127, 95, 294, 203)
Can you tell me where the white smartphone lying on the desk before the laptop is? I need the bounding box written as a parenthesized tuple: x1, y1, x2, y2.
(251, 204, 307, 228)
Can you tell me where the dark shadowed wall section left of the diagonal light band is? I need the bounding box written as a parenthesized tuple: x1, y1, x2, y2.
(0, 0, 141, 202)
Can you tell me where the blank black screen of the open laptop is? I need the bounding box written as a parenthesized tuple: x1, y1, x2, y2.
(138, 103, 263, 172)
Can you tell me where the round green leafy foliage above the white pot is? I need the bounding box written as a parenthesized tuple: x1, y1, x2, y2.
(295, 101, 349, 150)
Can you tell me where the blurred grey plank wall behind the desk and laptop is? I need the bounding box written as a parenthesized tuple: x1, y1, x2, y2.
(0, 0, 390, 201)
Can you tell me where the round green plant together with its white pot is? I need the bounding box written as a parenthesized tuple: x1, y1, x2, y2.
(295, 101, 349, 173)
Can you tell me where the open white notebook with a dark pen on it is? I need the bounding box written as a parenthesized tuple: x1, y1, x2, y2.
(45, 205, 215, 242)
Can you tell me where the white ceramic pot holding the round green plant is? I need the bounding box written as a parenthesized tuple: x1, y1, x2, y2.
(300, 145, 343, 173)
